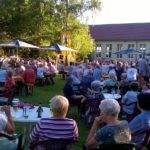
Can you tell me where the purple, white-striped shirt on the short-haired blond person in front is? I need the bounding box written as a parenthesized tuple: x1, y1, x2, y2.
(30, 117, 78, 141)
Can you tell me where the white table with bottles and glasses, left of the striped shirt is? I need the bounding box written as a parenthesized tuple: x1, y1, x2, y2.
(11, 106, 51, 148)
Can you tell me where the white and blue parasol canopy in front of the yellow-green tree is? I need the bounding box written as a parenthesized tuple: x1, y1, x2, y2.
(41, 43, 77, 52)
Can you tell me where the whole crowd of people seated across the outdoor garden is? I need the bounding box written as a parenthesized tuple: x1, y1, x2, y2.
(0, 56, 150, 149)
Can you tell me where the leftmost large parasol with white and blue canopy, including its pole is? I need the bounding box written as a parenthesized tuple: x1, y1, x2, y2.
(0, 40, 39, 57)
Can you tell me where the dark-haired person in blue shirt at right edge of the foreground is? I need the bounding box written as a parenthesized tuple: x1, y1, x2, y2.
(129, 93, 150, 149)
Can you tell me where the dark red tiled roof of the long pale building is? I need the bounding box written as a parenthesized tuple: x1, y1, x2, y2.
(89, 23, 150, 41)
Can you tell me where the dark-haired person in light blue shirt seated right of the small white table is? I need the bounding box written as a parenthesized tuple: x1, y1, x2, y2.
(121, 82, 139, 118)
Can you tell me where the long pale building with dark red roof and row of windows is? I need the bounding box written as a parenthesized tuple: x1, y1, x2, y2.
(89, 23, 150, 60)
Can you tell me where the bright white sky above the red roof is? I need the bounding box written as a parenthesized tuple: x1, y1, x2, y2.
(83, 0, 150, 24)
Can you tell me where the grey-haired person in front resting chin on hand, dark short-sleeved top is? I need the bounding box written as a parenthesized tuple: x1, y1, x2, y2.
(86, 99, 131, 149)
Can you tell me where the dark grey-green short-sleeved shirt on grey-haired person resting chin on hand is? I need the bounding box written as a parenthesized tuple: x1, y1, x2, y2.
(95, 120, 130, 144)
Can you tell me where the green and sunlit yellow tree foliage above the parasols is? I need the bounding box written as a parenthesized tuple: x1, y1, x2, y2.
(0, 0, 101, 57)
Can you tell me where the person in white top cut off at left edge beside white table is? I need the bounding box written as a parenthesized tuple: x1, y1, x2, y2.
(0, 106, 15, 134)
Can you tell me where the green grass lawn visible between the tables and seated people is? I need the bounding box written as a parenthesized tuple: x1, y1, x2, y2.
(16, 76, 90, 150)
